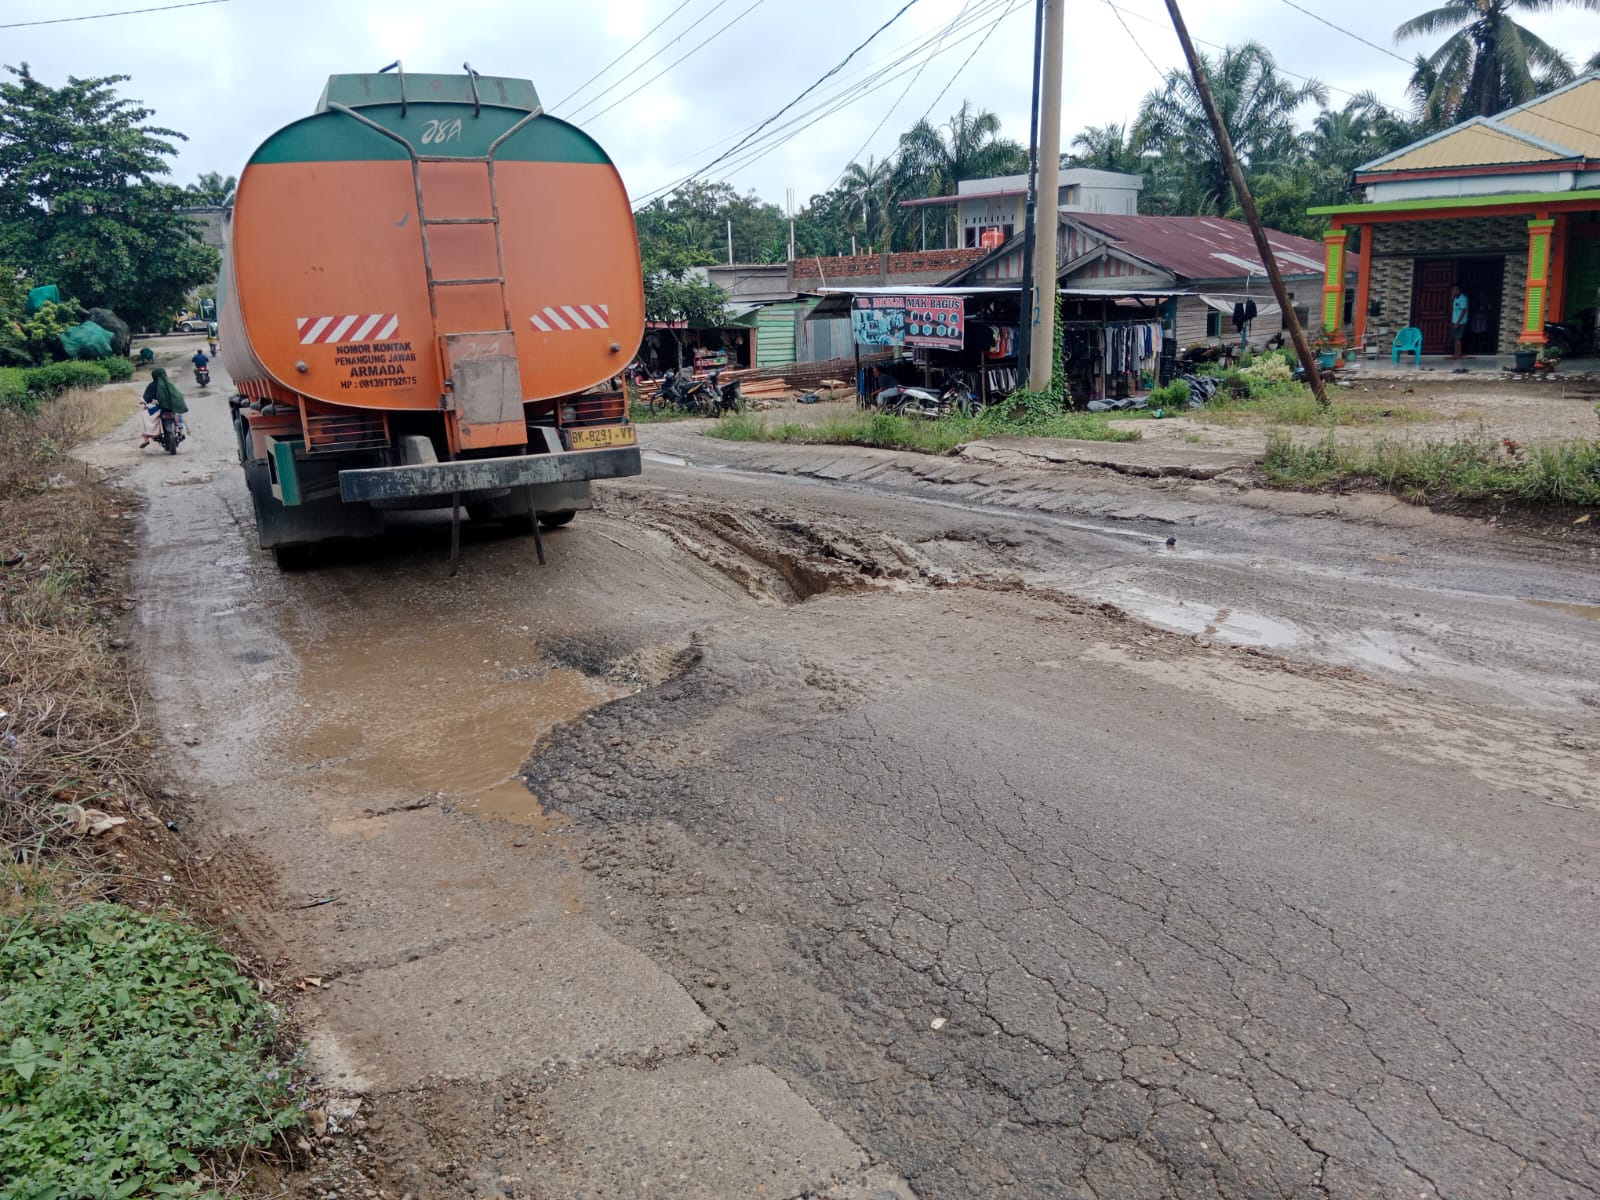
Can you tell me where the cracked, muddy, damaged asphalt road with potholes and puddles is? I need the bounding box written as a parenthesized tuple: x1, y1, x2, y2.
(106, 387, 1600, 1200)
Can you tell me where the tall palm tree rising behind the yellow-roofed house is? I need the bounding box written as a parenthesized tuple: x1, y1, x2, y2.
(1395, 0, 1600, 122)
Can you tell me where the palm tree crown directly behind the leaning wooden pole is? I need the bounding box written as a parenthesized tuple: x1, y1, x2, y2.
(1134, 43, 1324, 216)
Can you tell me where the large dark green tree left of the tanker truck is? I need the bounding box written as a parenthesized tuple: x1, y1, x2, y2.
(0, 62, 219, 336)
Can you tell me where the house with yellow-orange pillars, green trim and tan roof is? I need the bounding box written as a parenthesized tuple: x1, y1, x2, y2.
(1310, 74, 1600, 354)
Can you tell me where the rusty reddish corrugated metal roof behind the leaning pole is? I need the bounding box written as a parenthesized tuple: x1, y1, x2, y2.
(1064, 213, 1323, 280)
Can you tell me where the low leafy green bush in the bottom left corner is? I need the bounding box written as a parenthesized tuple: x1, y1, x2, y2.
(0, 902, 299, 1197)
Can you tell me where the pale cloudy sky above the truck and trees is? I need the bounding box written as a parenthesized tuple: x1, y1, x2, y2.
(0, 0, 1600, 203)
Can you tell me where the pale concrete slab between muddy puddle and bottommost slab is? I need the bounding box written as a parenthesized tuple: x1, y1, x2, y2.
(306, 917, 714, 1093)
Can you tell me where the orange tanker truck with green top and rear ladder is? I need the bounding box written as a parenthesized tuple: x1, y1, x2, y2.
(219, 69, 645, 565)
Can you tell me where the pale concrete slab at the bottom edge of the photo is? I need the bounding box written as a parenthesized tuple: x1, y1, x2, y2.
(530, 1062, 910, 1200)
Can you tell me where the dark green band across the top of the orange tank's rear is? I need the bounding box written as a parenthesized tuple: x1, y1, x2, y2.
(250, 102, 611, 165)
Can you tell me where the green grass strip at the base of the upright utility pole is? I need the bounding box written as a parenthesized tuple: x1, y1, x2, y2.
(704, 410, 1139, 454)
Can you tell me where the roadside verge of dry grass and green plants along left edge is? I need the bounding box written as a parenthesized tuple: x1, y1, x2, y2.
(0, 390, 299, 1200)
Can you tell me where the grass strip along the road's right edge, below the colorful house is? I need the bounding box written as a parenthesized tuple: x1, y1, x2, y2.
(1262, 429, 1600, 509)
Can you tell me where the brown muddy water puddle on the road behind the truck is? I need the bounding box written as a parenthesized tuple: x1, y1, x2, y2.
(282, 624, 629, 827)
